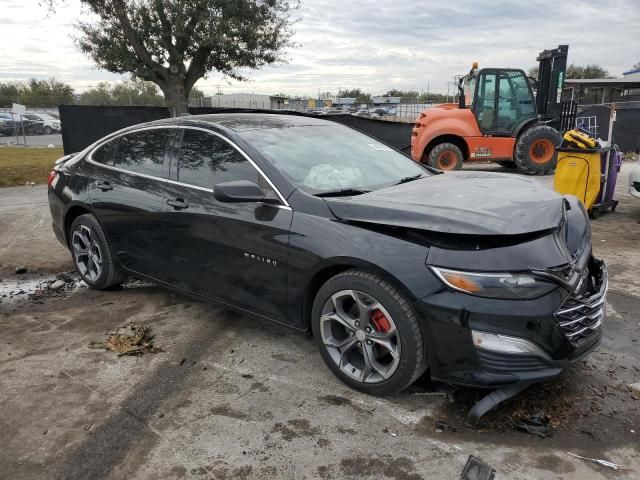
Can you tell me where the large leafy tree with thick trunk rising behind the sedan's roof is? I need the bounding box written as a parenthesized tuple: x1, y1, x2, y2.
(70, 0, 297, 115)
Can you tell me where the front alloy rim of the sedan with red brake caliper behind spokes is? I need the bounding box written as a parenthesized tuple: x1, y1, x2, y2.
(320, 290, 400, 383)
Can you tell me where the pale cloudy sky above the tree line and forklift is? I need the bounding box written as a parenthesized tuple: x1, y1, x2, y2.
(0, 0, 640, 96)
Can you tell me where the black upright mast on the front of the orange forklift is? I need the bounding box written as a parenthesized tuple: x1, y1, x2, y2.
(536, 45, 569, 122)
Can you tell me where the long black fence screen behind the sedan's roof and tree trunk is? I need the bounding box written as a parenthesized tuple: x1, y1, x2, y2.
(59, 105, 413, 154)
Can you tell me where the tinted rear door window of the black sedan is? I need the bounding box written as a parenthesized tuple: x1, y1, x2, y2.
(115, 129, 171, 177)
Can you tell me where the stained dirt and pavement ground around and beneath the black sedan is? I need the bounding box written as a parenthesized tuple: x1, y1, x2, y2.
(0, 164, 640, 480)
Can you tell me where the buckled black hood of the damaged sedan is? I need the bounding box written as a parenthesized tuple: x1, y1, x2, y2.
(325, 172, 565, 235)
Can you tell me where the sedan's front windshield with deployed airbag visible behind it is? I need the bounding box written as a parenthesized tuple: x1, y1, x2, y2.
(240, 125, 428, 193)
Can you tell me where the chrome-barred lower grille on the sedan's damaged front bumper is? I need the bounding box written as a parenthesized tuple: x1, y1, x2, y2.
(555, 270, 607, 345)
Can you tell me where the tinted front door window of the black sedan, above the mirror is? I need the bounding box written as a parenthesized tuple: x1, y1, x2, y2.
(178, 129, 266, 188)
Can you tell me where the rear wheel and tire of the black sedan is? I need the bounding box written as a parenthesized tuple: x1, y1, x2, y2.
(68, 214, 125, 290)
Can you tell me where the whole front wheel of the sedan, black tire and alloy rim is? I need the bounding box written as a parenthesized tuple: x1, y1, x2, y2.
(311, 270, 427, 395)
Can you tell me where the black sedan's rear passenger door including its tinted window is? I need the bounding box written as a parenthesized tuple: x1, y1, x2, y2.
(89, 128, 177, 278)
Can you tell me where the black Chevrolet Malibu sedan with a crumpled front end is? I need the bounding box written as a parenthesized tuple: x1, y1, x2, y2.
(49, 114, 607, 395)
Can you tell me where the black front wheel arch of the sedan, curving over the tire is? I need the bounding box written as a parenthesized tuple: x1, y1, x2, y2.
(302, 257, 415, 330)
